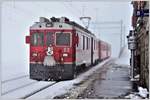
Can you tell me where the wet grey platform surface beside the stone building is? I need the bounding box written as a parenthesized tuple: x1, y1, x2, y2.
(79, 63, 132, 99)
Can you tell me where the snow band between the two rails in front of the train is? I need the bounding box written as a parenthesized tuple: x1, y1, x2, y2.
(2, 81, 55, 99)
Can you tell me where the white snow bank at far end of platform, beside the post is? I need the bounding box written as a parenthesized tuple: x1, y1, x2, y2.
(115, 45, 130, 65)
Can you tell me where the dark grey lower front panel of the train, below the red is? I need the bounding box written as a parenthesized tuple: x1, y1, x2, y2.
(30, 64, 75, 81)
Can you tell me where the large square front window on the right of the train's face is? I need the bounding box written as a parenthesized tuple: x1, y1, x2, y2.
(56, 33, 70, 46)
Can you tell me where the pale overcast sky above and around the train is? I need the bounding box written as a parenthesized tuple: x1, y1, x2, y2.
(2, 1, 132, 79)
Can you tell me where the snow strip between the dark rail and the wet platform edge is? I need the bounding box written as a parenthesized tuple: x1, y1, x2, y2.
(28, 58, 111, 99)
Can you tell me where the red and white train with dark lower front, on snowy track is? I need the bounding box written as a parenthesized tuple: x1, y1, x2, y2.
(26, 17, 111, 80)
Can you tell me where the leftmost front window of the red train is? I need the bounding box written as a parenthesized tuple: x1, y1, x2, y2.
(31, 33, 44, 46)
